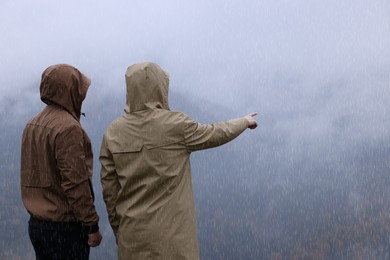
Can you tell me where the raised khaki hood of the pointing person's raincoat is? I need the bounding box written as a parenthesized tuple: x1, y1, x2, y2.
(125, 62, 169, 113)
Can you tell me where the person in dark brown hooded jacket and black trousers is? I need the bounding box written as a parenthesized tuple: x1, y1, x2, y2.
(20, 64, 102, 259)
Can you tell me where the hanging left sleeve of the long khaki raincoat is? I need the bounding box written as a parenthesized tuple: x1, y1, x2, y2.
(99, 136, 120, 234)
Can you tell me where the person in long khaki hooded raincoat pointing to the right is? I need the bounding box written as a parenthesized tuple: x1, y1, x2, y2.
(99, 62, 257, 260)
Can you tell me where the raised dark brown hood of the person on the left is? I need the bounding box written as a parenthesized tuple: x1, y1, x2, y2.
(40, 64, 91, 119)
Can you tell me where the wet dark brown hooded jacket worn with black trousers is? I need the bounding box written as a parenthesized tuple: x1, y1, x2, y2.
(21, 64, 99, 233)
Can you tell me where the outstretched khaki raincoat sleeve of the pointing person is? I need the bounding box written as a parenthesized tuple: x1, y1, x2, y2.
(184, 117, 248, 152)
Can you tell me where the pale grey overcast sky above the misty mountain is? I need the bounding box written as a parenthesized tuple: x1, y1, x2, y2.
(0, 0, 390, 156)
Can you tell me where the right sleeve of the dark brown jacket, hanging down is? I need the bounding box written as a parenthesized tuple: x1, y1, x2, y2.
(55, 127, 99, 233)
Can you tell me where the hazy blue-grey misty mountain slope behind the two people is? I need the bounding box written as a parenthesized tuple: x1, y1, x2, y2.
(0, 88, 390, 259)
